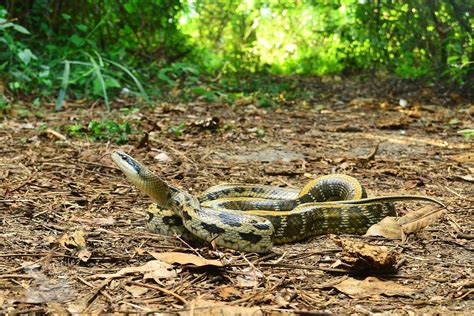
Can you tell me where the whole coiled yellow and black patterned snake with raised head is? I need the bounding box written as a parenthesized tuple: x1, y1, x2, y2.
(111, 151, 444, 253)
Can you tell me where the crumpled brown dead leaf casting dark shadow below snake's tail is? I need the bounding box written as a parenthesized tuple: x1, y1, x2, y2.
(332, 238, 398, 270)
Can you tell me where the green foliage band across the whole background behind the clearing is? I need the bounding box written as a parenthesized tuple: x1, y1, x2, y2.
(0, 0, 474, 100)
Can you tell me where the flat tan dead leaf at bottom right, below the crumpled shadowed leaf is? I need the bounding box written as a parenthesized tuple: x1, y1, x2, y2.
(334, 277, 415, 298)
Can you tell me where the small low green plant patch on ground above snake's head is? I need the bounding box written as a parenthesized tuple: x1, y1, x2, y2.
(64, 120, 134, 144)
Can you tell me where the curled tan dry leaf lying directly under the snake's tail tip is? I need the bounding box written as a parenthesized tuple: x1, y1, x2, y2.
(365, 206, 444, 239)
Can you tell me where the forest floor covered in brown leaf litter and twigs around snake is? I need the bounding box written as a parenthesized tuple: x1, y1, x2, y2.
(0, 80, 474, 315)
